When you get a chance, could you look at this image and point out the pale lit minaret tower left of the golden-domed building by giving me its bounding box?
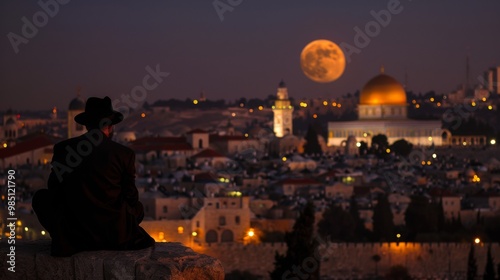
[273,80,293,137]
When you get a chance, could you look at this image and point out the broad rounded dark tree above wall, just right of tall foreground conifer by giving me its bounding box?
[318,204,356,241]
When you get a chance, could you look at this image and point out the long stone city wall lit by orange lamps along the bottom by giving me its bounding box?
[193,243,500,279]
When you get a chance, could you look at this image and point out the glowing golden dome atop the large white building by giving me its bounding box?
[359,74,406,105]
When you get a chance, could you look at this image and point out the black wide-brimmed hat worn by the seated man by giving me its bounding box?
[75,96,123,125]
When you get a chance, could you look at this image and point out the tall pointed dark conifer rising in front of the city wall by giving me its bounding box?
[269,202,321,280]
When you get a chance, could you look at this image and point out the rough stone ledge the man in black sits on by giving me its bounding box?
[0,240,224,280]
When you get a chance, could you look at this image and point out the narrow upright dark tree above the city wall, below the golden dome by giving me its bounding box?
[373,195,395,241]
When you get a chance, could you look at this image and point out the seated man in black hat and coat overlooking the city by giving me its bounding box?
[33,96,154,256]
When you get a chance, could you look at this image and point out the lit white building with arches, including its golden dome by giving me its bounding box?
[328,69,451,146]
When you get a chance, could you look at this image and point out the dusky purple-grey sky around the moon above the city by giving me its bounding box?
[0,0,500,110]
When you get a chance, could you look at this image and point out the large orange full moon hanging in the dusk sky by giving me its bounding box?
[300,40,345,83]
